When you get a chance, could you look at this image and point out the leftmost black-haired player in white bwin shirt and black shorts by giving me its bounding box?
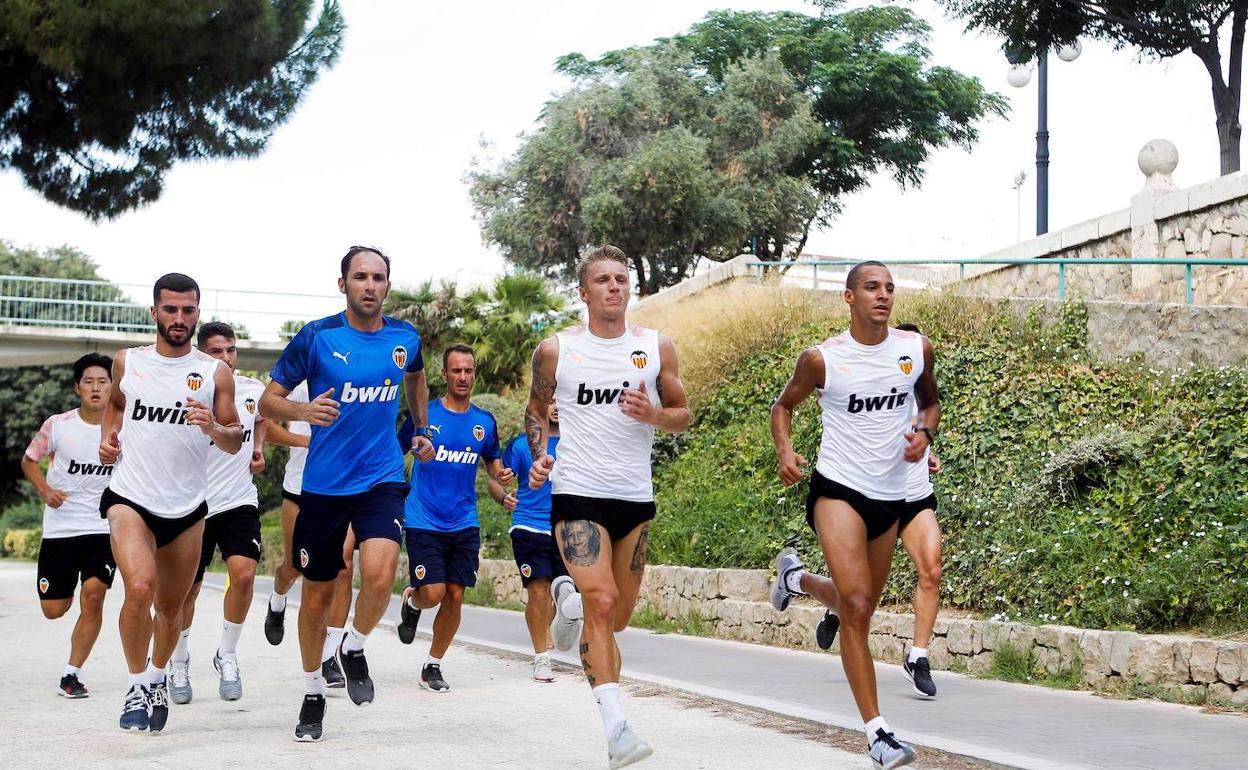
[21,353,117,698]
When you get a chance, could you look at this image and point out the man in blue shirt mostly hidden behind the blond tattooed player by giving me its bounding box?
[489,401,568,681]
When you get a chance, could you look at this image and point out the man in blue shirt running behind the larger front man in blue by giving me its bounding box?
[398,344,514,693]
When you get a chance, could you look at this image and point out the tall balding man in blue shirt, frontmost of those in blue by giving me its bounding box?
[260,246,433,741]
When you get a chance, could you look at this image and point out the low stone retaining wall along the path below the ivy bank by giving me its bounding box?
[478,559,1248,704]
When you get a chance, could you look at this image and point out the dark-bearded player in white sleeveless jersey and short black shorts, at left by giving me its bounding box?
[100,273,242,733]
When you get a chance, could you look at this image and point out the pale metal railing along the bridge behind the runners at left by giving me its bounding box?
[0,275,342,341]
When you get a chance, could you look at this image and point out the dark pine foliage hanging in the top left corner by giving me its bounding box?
[0,0,344,220]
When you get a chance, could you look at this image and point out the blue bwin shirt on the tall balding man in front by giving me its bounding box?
[271,312,424,495]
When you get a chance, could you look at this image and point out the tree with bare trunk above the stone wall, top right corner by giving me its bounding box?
[938,0,1248,173]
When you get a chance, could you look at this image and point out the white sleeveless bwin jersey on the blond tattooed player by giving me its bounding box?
[550,323,659,503]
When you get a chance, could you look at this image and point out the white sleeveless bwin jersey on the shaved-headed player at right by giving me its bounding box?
[815,329,924,500]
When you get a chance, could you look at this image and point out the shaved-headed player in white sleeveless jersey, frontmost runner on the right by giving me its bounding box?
[771,262,940,768]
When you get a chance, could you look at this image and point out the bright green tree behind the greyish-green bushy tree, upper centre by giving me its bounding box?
[558,0,1007,260]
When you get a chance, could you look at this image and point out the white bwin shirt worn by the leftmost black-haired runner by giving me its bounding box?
[26,409,112,539]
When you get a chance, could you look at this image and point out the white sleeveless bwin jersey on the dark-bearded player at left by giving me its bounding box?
[109,344,226,518]
